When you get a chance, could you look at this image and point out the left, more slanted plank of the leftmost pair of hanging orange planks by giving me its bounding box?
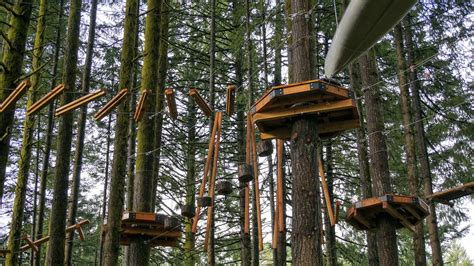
[192,112,222,233]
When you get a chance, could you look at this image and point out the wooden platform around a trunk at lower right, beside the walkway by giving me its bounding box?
[346,194,429,231]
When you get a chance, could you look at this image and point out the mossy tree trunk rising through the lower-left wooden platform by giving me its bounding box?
[130,0,161,266]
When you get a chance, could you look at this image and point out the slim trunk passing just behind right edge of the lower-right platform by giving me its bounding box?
[393,24,426,266]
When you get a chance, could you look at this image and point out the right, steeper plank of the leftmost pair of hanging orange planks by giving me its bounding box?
[204,112,222,251]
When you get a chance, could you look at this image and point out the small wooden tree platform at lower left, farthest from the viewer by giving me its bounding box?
[102,212,181,247]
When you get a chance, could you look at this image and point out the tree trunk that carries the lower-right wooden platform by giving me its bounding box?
[359,51,398,266]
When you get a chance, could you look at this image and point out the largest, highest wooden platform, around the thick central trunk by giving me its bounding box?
[251,80,359,139]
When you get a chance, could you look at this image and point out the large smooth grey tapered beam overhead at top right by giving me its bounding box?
[324,0,417,78]
